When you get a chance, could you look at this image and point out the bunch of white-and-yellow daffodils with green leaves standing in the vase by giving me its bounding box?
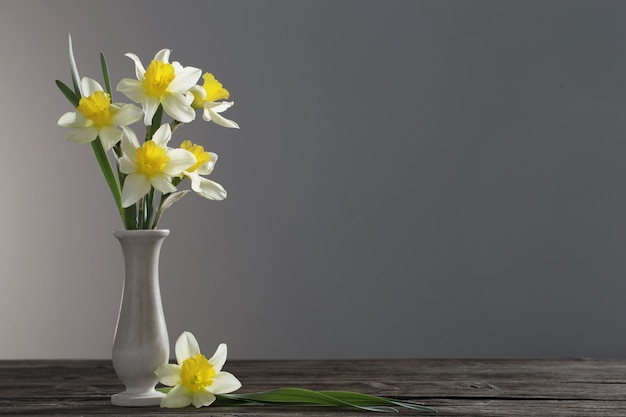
[56,37,239,230]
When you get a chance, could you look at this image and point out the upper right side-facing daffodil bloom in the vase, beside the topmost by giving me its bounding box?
[190,72,239,129]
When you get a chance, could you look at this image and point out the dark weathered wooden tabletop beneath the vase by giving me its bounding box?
[0,359,626,417]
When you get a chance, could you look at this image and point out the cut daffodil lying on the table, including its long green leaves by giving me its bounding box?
[155,332,437,413]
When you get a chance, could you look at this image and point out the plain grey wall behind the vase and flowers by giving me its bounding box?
[0,0,626,358]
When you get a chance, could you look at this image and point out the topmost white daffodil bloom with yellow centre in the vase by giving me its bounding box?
[117,49,202,126]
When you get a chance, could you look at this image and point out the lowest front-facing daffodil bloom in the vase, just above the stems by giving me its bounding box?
[120,124,196,207]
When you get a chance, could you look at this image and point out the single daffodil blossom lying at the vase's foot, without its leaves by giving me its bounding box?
[155,332,241,408]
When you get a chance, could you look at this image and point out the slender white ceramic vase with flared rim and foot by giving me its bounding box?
[111,230,170,406]
